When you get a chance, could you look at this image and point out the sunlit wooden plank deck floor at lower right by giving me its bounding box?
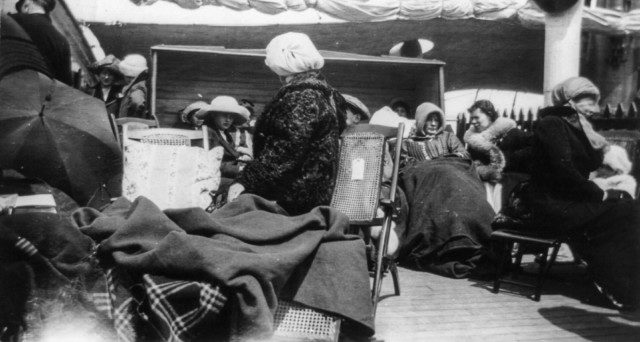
[375,255,640,342]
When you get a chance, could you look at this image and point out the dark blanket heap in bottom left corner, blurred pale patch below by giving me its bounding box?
[0,212,115,341]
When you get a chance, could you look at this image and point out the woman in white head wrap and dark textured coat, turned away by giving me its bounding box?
[228,32,346,215]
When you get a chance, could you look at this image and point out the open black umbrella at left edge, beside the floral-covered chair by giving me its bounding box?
[0,70,122,205]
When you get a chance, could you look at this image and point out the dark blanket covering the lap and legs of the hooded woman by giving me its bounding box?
[400,157,494,278]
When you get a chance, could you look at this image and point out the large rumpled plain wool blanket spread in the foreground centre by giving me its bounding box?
[76,195,373,338]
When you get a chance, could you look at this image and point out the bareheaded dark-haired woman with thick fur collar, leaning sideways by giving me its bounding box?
[464,100,531,211]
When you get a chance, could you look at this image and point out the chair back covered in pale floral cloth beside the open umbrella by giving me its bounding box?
[122,124,218,209]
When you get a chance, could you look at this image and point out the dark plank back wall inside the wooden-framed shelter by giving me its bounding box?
[157,51,439,126]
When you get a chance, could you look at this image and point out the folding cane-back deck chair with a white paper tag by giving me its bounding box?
[331,123,404,315]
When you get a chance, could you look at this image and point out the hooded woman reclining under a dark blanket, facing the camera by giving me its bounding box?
[384,103,493,278]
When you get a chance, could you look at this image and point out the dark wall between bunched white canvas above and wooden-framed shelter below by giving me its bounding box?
[90,19,544,92]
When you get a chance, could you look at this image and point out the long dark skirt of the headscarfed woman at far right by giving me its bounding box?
[528,190,640,308]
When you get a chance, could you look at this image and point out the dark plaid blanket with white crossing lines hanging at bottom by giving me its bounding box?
[97,269,227,342]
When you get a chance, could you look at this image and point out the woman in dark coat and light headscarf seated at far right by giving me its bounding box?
[522,77,640,309]
